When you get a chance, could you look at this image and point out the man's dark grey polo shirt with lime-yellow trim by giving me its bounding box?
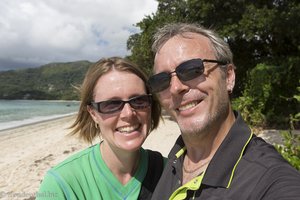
[152,112,300,200]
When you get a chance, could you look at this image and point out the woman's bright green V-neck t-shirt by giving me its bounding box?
[36,144,148,200]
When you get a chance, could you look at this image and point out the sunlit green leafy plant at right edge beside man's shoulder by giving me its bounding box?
[275,87,300,170]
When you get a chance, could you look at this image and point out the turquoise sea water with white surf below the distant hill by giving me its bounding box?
[0,100,79,130]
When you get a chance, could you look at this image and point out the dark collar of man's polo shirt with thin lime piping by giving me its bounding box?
[168,112,253,188]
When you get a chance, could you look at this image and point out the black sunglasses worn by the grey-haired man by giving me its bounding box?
[148,58,227,93]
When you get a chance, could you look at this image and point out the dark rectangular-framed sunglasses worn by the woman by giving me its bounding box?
[90,94,152,114]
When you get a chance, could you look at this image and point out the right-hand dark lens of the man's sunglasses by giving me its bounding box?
[176,59,204,81]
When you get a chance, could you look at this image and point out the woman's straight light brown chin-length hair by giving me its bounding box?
[70,57,161,143]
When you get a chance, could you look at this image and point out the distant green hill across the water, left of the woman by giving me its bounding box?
[0,61,92,100]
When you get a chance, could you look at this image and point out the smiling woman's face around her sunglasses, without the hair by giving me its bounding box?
[89,70,151,151]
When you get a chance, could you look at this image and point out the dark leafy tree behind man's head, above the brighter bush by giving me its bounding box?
[127,0,300,96]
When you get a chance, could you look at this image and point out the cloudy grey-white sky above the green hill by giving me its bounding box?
[0,0,158,71]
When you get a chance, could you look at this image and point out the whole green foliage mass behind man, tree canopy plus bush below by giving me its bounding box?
[127,0,300,126]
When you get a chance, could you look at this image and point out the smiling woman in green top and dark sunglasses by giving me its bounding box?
[37,57,163,200]
